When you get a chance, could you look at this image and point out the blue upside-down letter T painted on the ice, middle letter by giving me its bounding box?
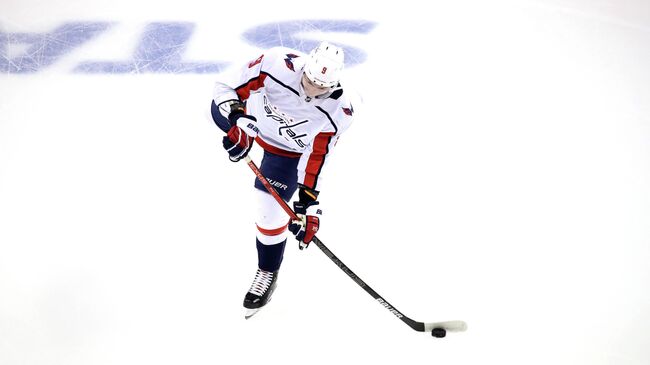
[75,23,227,74]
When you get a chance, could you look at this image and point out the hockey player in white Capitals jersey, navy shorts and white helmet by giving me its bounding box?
[211,42,354,318]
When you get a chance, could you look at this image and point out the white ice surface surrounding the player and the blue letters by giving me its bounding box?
[0,0,650,365]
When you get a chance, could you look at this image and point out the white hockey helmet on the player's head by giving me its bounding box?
[305,42,344,88]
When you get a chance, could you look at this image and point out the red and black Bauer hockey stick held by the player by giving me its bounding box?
[244,156,467,337]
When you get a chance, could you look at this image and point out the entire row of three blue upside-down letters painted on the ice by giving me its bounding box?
[0,20,376,74]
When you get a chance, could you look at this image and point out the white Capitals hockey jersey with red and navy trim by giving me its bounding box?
[214,47,354,191]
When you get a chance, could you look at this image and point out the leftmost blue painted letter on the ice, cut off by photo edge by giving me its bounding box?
[0,22,109,73]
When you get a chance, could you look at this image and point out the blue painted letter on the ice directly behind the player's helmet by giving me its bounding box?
[243,20,376,66]
